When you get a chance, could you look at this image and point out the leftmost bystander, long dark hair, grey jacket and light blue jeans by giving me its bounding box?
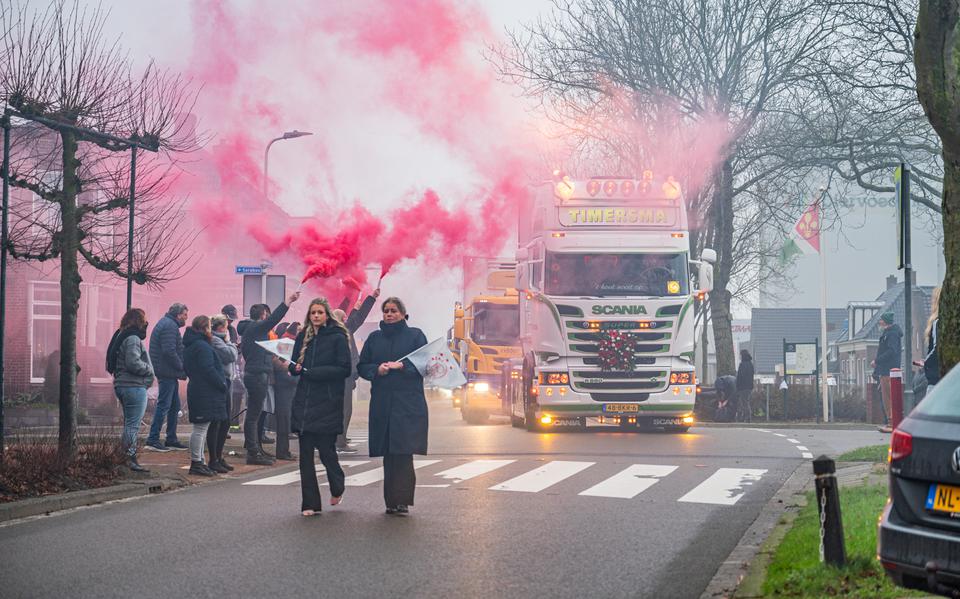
[107,308,153,472]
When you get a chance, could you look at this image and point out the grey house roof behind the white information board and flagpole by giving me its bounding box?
[750,308,847,374]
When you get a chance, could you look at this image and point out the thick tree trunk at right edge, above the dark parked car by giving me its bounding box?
[914,0,960,374]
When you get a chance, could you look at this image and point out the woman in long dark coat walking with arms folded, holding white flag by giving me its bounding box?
[357,297,428,515]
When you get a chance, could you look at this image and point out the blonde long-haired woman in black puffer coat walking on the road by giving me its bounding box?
[289,298,350,516]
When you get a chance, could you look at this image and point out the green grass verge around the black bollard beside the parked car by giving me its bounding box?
[763,485,926,599]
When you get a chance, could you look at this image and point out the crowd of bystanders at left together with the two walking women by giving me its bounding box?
[106,289,428,516]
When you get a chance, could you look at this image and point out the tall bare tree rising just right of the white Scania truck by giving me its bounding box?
[496,0,837,374]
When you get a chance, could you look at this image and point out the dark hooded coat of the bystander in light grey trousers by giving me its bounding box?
[183,327,230,422]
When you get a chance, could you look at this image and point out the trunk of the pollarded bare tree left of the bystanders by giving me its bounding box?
[59,132,81,463]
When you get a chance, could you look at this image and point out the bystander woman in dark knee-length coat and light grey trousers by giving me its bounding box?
[183,316,229,476]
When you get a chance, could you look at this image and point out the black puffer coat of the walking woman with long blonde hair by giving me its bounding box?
[290,324,350,435]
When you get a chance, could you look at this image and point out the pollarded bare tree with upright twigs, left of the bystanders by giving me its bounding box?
[0,0,195,460]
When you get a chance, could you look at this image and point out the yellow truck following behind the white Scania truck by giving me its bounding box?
[452,257,520,424]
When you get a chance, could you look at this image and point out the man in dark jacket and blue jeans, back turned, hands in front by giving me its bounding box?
[146,303,189,451]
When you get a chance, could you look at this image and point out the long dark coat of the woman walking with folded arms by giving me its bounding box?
[357,320,429,457]
